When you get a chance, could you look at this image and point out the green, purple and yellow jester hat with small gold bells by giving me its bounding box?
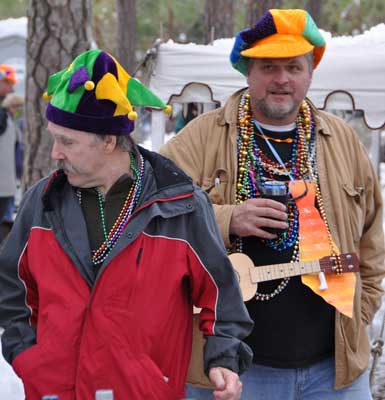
[43,49,171,135]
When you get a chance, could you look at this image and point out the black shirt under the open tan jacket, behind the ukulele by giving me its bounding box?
[243,130,335,368]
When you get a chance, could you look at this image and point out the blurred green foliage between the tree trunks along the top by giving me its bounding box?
[0,0,385,60]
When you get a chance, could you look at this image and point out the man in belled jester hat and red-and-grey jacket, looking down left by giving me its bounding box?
[0,50,253,400]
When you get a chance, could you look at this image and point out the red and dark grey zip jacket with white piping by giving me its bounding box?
[0,149,252,400]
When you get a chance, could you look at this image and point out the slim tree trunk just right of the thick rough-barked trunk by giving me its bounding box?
[115,0,136,74]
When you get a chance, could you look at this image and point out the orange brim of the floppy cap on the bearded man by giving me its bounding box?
[241,33,325,68]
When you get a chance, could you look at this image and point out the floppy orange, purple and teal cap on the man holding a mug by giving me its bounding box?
[230,9,326,75]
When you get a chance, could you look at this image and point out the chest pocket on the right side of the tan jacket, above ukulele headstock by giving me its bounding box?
[342,183,365,243]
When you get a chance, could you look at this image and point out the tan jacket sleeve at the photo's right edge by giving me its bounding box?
[360,145,385,324]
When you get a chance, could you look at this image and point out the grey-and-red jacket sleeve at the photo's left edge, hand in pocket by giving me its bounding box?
[0,184,38,364]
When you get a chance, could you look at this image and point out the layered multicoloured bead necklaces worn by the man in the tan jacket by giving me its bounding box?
[236,92,320,301]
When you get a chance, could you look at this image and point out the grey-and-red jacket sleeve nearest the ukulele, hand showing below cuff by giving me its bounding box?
[185,188,253,374]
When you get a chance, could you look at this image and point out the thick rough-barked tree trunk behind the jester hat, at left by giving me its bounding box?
[23,0,92,189]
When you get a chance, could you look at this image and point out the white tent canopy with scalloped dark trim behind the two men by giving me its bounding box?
[149,24,385,149]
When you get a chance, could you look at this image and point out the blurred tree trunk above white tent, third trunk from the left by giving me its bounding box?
[205,0,234,44]
